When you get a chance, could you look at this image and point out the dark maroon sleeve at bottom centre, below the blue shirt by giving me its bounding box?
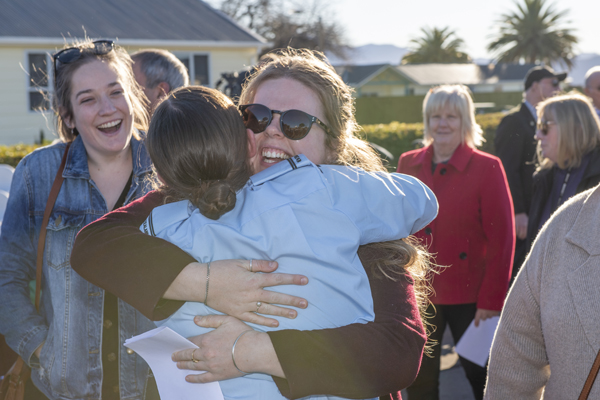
[269,242,426,399]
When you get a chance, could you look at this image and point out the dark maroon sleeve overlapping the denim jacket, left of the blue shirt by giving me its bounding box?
[71,192,196,321]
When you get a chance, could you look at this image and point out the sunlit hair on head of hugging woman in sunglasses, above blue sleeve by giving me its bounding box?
[240,48,386,171]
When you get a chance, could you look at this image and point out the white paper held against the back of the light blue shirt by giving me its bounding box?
[125,326,223,400]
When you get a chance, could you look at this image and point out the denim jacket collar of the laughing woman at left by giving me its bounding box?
[63,132,152,179]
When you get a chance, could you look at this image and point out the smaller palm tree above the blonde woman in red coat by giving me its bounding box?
[402,27,471,64]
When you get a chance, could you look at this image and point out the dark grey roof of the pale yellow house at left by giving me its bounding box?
[0,0,266,46]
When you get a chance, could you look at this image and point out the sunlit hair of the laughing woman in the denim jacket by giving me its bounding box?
[52,39,148,142]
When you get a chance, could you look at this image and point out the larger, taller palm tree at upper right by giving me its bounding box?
[488,0,578,68]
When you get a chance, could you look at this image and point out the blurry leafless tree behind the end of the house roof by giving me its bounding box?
[220,0,348,57]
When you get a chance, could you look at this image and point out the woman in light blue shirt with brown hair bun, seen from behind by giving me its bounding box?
[137,83,437,400]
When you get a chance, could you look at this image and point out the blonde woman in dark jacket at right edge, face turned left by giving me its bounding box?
[527,92,600,248]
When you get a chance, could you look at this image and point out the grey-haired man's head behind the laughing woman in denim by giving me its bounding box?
[131,49,190,115]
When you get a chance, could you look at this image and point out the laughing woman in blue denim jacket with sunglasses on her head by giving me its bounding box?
[0,40,153,399]
